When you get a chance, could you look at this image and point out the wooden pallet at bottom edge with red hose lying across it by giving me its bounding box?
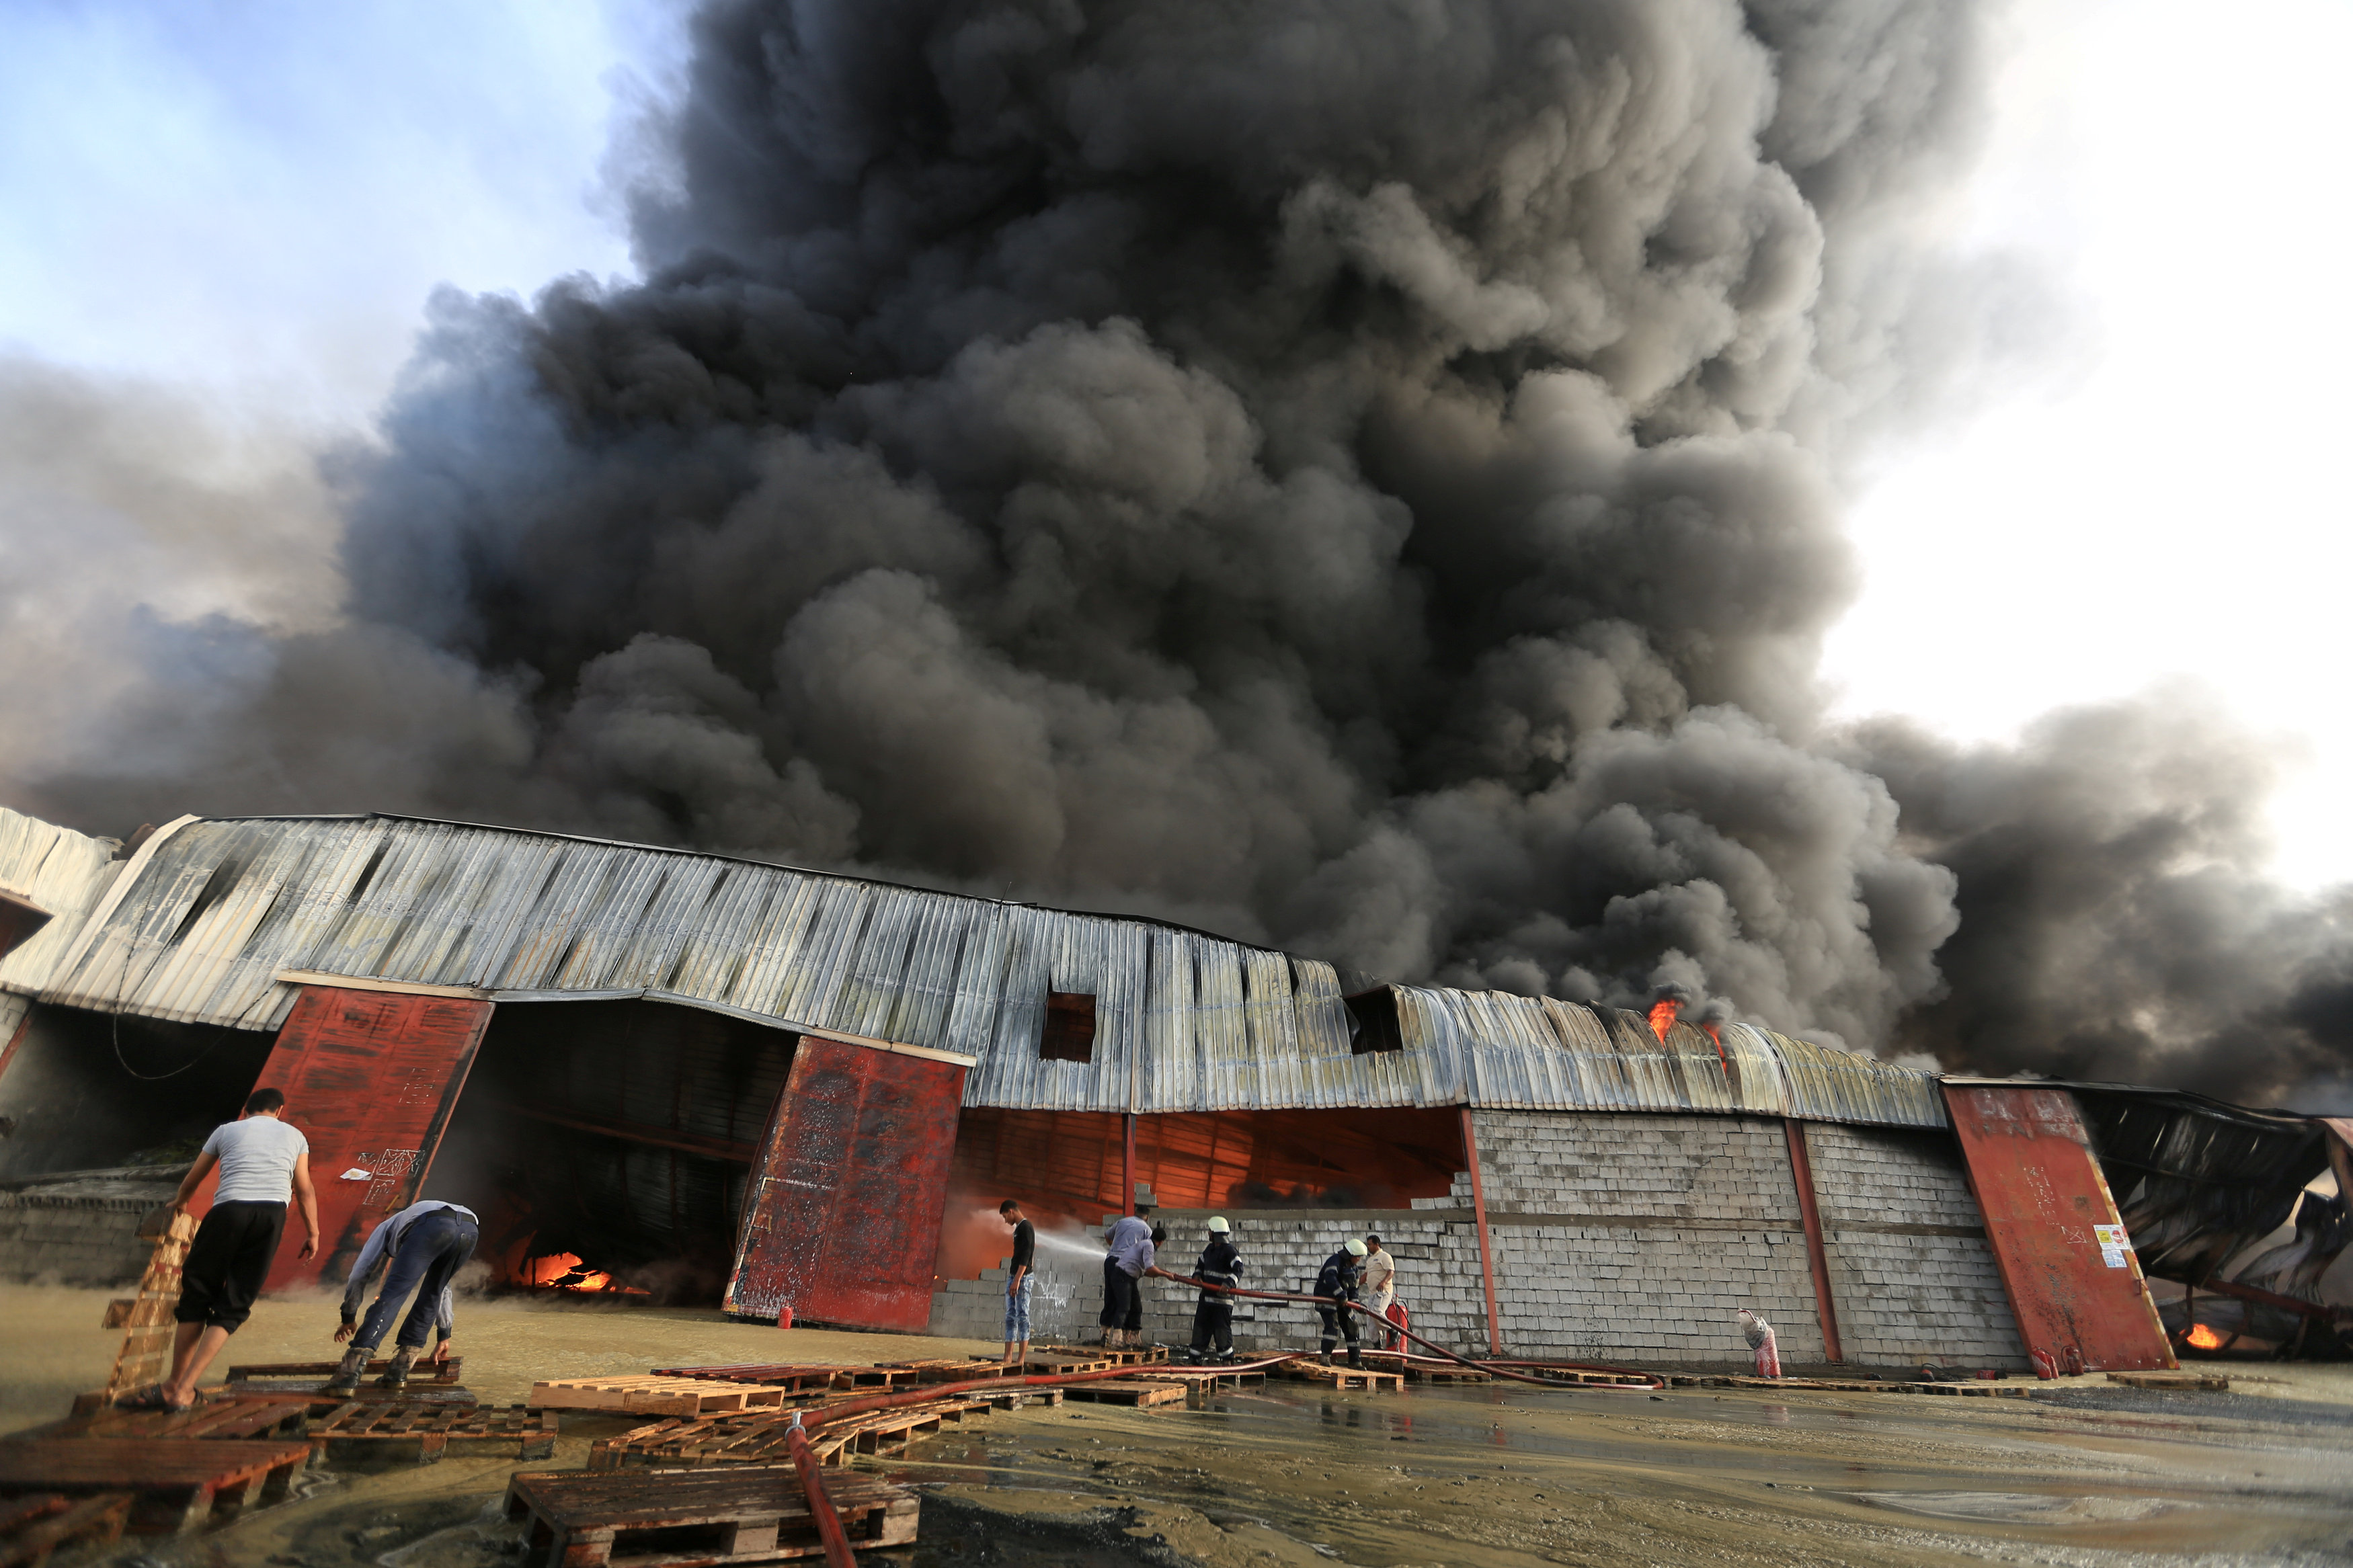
[506,1464,920,1568]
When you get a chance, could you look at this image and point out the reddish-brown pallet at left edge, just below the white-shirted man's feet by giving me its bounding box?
[0,1436,311,1535]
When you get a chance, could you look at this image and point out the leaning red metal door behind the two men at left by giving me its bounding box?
[202,985,492,1290]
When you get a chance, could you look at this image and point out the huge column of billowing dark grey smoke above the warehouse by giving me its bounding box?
[4,0,2334,1104]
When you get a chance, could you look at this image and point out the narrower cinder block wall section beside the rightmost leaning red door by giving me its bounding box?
[1805,1121,2028,1370]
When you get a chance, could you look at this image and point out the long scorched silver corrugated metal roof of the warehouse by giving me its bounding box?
[42,816,1944,1126]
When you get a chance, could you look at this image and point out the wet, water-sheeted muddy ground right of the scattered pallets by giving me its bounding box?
[866,1383,2353,1568]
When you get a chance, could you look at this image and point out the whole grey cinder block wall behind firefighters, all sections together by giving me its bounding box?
[932,1112,2026,1368]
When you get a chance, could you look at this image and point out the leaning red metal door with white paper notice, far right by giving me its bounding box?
[1944,1083,2174,1373]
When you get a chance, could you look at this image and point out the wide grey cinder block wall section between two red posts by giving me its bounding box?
[1457,1112,1824,1364]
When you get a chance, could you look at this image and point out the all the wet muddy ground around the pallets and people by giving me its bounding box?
[0,1288,2353,1568]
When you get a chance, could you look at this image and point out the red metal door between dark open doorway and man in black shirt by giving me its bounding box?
[725,1034,965,1331]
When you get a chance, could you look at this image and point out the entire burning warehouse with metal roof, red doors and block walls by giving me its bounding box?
[0,813,2353,1370]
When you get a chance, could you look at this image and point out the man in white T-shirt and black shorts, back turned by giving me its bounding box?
[122,1088,318,1411]
